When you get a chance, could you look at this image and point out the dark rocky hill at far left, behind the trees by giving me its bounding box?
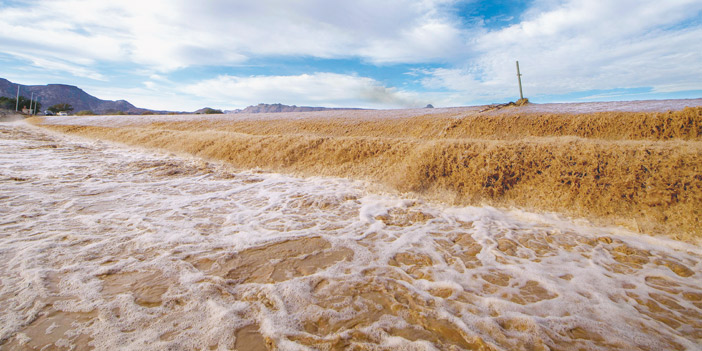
[0,78,153,114]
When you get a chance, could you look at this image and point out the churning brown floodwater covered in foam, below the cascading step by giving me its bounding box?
[0,122,702,350]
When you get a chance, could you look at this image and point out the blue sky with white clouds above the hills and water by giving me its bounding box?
[0,0,702,111]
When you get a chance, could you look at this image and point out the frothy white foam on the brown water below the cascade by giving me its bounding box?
[0,124,702,350]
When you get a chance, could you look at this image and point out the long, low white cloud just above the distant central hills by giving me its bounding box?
[182,73,428,108]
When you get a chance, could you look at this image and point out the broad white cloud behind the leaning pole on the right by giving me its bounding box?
[423,0,702,101]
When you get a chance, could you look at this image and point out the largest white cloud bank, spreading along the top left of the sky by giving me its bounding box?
[0,0,472,72]
